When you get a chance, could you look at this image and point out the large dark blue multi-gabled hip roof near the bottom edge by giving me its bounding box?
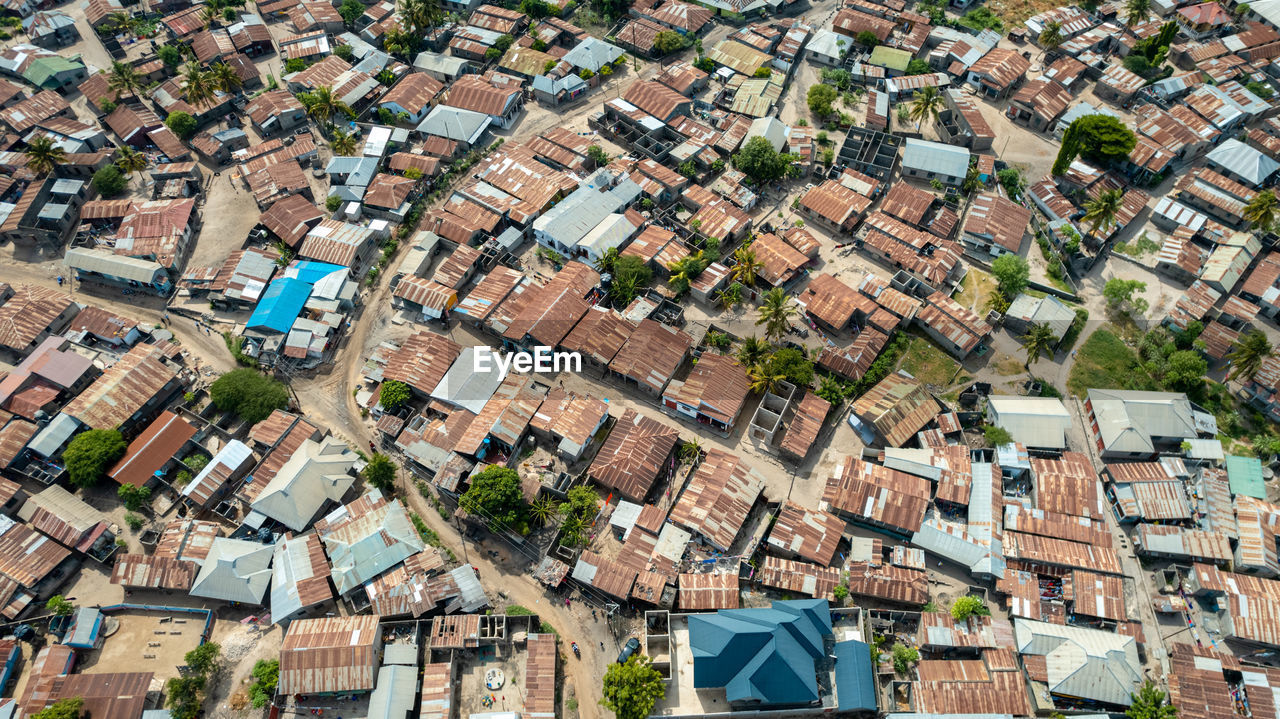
[689,599,834,706]
